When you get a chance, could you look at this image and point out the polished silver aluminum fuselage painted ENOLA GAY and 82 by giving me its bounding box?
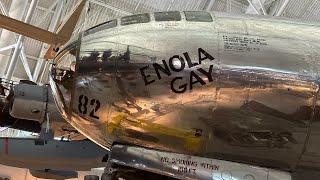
[51,13,320,170]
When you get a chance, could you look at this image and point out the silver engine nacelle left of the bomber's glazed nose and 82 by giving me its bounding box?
[10,84,64,122]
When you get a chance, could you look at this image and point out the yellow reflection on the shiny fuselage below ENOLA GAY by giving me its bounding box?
[106,114,204,153]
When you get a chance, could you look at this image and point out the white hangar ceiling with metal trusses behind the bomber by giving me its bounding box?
[0,0,320,84]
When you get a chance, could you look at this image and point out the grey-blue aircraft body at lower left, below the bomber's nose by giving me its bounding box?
[0,138,107,179]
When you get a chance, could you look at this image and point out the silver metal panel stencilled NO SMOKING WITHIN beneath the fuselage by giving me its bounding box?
[110,145,291,180]
